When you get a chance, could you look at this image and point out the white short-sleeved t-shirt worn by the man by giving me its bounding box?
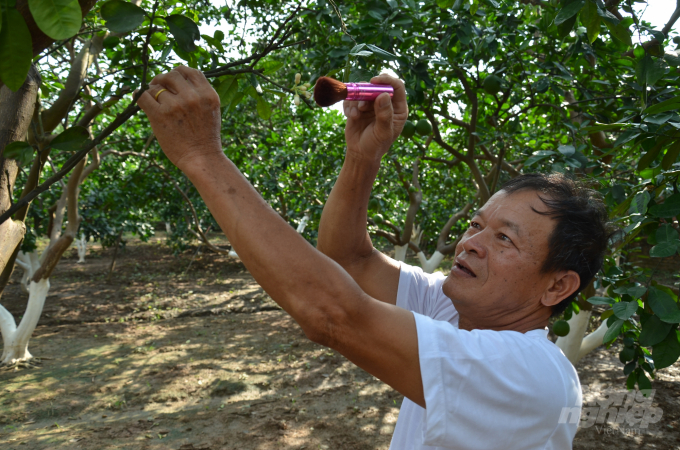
[390,264,582,450]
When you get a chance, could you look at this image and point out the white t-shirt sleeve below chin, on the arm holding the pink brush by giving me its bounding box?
[397,263,458,322]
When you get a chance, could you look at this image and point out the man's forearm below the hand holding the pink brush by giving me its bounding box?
[317,156,380,267]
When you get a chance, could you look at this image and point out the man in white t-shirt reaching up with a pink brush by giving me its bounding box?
[138,67,608,450]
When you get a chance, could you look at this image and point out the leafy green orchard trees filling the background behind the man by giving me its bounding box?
[0,0,680,388]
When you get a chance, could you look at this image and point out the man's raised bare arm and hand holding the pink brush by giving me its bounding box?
[317,74,408,304]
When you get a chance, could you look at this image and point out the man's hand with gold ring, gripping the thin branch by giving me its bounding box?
[137,66,222,170]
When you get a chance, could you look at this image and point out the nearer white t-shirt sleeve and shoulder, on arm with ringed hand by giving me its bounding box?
[414,314,578,450]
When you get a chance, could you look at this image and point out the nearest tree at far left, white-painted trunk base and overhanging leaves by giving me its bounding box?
[0,0,314,365]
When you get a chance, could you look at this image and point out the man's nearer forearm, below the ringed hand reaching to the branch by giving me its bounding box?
[182,154,365,337]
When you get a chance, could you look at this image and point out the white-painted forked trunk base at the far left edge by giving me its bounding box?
[0,278,50,364]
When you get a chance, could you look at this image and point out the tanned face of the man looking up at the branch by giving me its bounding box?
[443,191,555,321]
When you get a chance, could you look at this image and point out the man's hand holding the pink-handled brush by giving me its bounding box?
[343,73,408,162]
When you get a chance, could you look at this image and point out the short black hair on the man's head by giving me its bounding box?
[501,173,615,317]
